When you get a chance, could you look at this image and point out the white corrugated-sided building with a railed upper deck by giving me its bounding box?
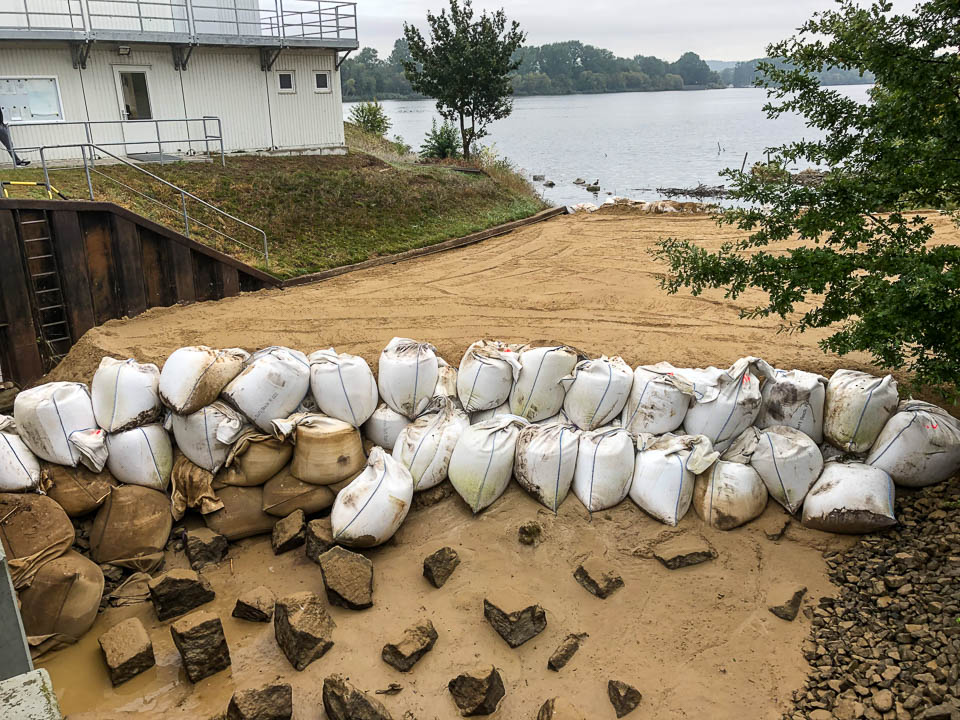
[0,0,358,162]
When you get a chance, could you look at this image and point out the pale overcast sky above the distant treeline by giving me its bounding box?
[357,0,915,60]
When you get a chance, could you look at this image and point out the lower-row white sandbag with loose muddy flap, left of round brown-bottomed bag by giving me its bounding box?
[630,435,719,526]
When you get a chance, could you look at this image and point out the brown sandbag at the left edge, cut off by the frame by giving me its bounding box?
[0,493,74,590]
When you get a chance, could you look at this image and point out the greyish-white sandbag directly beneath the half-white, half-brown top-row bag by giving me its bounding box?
[167,400,250,473]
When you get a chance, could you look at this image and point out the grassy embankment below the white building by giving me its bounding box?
[0,126,545,278]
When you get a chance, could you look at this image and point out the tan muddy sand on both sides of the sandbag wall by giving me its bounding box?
[39,212,960,720]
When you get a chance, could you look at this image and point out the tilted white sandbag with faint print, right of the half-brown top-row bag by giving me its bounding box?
[223,347,310,433]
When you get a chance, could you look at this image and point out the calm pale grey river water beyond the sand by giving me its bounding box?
[344,85,870,205]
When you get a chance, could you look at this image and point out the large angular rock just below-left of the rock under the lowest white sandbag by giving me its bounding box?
[273,592,337,670]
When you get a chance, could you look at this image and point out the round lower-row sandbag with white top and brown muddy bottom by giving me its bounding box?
[693,460,768,530]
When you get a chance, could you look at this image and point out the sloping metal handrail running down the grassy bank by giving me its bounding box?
[40,143,270,267]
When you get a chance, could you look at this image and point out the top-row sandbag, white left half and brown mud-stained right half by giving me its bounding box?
[158,345,250,415]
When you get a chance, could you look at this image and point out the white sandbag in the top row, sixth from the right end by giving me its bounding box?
[561,355,633,430]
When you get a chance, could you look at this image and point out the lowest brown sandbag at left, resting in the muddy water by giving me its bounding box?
[20,550,103,657]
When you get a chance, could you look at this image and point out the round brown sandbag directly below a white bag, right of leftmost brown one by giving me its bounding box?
[90,485,173,572]
